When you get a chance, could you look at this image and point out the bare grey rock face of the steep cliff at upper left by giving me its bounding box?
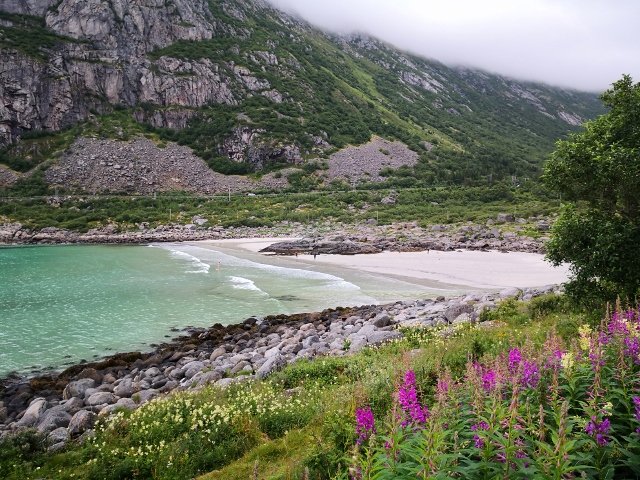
[0,0,238,146]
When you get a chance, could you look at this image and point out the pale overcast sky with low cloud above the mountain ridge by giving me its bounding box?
[270,0,640,92]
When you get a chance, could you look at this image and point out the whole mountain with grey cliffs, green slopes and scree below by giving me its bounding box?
[0,0,604,192]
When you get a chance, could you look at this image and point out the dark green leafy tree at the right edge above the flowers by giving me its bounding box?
[544,75,640,301]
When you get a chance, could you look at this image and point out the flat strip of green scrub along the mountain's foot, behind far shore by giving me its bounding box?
[0,182,558,235]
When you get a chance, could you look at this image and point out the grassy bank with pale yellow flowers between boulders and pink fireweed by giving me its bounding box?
[0,297,604,480]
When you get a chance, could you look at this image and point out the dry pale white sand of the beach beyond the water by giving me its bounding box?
[198,238,568,290]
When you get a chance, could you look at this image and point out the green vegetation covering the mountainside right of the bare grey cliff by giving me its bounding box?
[144,2,601,182]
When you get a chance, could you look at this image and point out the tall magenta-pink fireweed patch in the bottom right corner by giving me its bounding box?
[348,309,640,480]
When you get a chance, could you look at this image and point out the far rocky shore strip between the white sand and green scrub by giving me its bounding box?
[0,215,550,255]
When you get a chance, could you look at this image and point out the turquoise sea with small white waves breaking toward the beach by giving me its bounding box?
[0,244,450,377]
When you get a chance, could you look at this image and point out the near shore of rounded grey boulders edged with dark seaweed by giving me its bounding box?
[0,286,559,450]
